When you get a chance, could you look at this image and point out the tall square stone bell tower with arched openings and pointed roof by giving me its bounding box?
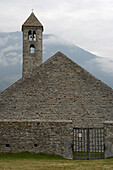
[22,12,43,76]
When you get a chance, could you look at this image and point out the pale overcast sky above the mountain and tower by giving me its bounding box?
[0,0,113,60]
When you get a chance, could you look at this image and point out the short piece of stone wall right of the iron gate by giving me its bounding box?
[104,121,113,158]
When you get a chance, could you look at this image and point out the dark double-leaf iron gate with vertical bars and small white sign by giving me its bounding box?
[73,128,104,159]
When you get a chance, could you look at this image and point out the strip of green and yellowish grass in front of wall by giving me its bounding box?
[0,153,113,170]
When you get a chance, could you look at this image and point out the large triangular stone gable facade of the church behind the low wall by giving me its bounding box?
[0,52,113,127]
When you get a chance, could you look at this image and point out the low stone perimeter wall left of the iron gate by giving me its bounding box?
[0,120,73,158]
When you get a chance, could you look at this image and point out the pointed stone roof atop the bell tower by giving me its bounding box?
[22,12,43,31]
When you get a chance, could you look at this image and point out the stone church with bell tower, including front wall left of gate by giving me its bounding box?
[0,12,113,158]
